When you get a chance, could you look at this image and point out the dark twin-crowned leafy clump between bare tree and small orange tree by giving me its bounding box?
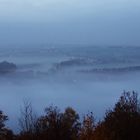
[37,106,80,140]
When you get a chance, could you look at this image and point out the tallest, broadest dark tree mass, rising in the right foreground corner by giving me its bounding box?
[95,92,140,140]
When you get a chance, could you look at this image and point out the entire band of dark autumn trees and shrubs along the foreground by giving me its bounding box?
[0,92,140,140]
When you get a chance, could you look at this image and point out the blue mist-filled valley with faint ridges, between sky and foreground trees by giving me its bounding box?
[0,46,140,132]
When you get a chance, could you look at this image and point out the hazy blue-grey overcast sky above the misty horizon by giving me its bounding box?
[0,0,140,46]
